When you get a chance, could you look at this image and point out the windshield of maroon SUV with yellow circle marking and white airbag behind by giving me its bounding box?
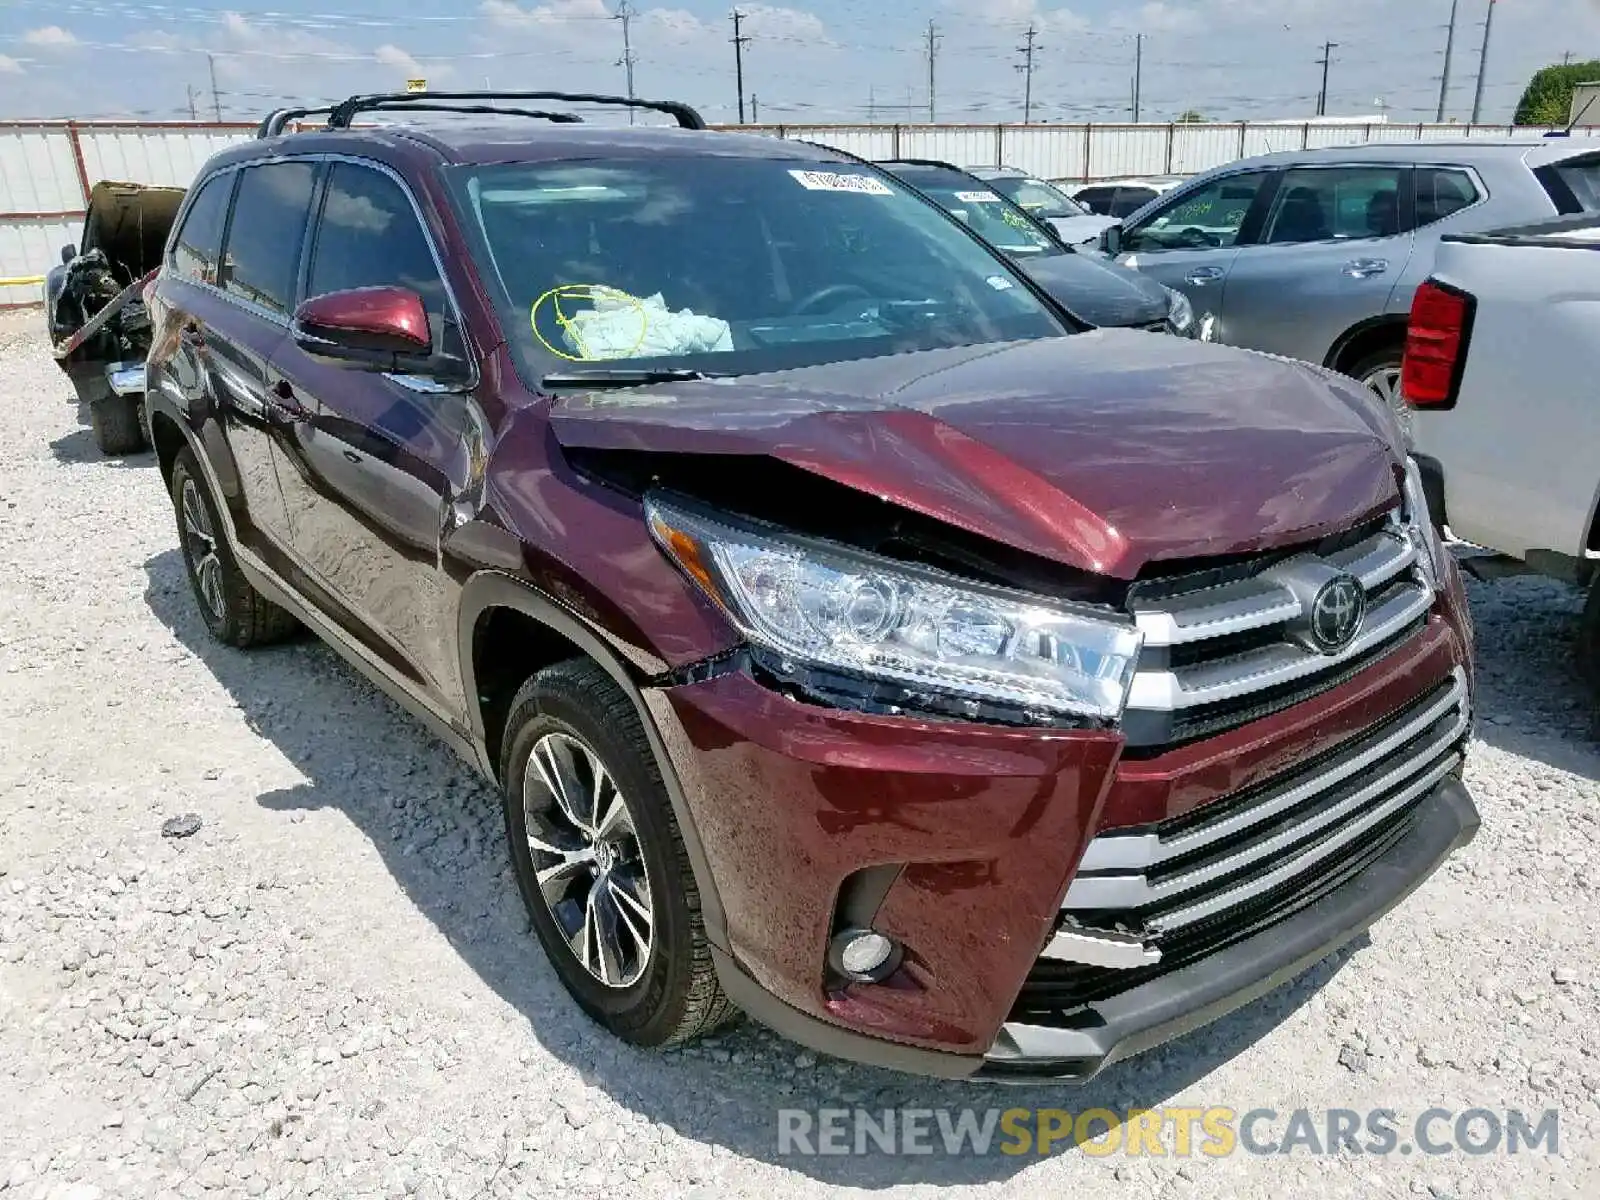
[446,157,1067,384]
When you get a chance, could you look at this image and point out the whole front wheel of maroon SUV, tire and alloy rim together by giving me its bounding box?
[501,659,738,1046]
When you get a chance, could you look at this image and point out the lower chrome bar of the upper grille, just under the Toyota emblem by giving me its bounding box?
[1128,584,1434,710]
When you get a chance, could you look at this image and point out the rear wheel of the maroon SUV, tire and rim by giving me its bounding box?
[173,446,299,650]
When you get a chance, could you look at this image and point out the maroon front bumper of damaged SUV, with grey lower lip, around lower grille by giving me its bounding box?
[645,605,1477,1078]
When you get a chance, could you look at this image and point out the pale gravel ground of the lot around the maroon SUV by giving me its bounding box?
[0,312,1600,1200]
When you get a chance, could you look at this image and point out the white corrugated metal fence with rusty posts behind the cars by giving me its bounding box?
[0,122,1600,306]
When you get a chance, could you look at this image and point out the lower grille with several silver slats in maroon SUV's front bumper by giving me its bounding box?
[1045,669,1470,957]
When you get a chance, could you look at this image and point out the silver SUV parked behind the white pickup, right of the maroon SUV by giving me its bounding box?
[1104,138,1600,416]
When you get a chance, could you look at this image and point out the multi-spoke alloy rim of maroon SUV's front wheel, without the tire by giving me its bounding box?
[522,733,654,987]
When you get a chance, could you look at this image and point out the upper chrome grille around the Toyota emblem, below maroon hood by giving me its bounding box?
[1125,514,1434,747]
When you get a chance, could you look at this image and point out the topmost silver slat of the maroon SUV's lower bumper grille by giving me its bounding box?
[1078,667,1467,872]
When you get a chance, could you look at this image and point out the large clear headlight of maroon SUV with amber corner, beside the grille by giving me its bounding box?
[645,498,1144,718]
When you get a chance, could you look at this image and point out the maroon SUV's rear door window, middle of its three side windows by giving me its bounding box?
[221,162,317,314]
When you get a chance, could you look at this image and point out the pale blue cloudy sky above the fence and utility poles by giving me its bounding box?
[0,0,1600,123]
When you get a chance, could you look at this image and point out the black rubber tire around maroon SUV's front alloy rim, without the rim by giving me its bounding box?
[501,659,741,1046]
